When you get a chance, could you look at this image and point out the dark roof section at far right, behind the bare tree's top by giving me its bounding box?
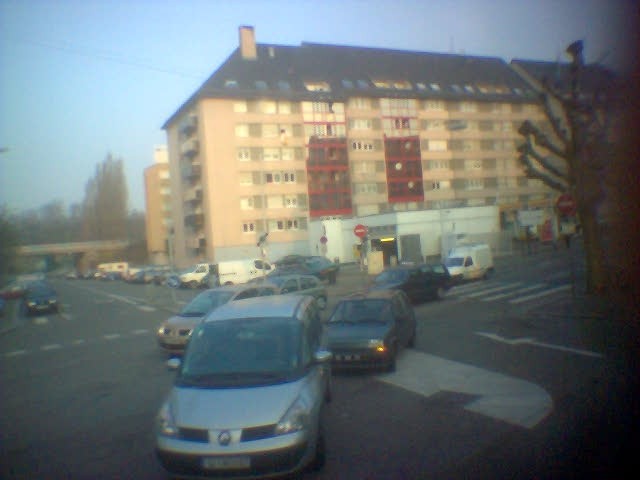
[511,59,616,94]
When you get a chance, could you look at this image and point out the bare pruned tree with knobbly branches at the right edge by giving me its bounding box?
[518,41,616,293]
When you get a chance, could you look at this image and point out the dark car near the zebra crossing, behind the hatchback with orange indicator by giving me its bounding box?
[369,263,453,303]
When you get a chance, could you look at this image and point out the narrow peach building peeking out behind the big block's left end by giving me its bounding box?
[144,145,173,265]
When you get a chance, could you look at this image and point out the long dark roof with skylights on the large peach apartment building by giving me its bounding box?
[163,43,535,128]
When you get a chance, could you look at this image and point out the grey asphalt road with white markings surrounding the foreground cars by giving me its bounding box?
[0,246,638,479]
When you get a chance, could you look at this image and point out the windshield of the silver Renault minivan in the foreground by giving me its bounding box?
[176,318,302,387]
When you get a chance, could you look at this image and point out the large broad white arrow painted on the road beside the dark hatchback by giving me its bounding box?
[377,350,553,428]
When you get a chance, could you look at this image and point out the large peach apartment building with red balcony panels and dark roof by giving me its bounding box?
[163,27,556,265]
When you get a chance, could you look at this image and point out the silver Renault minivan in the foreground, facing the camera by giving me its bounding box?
[156,295,331,479]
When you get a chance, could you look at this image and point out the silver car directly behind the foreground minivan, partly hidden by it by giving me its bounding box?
[157,284,279,354]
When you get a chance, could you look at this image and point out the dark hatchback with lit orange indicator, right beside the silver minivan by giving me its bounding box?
[327,290,416,371]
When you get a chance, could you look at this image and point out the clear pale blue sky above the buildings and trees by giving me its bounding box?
[0,0,639,213]
